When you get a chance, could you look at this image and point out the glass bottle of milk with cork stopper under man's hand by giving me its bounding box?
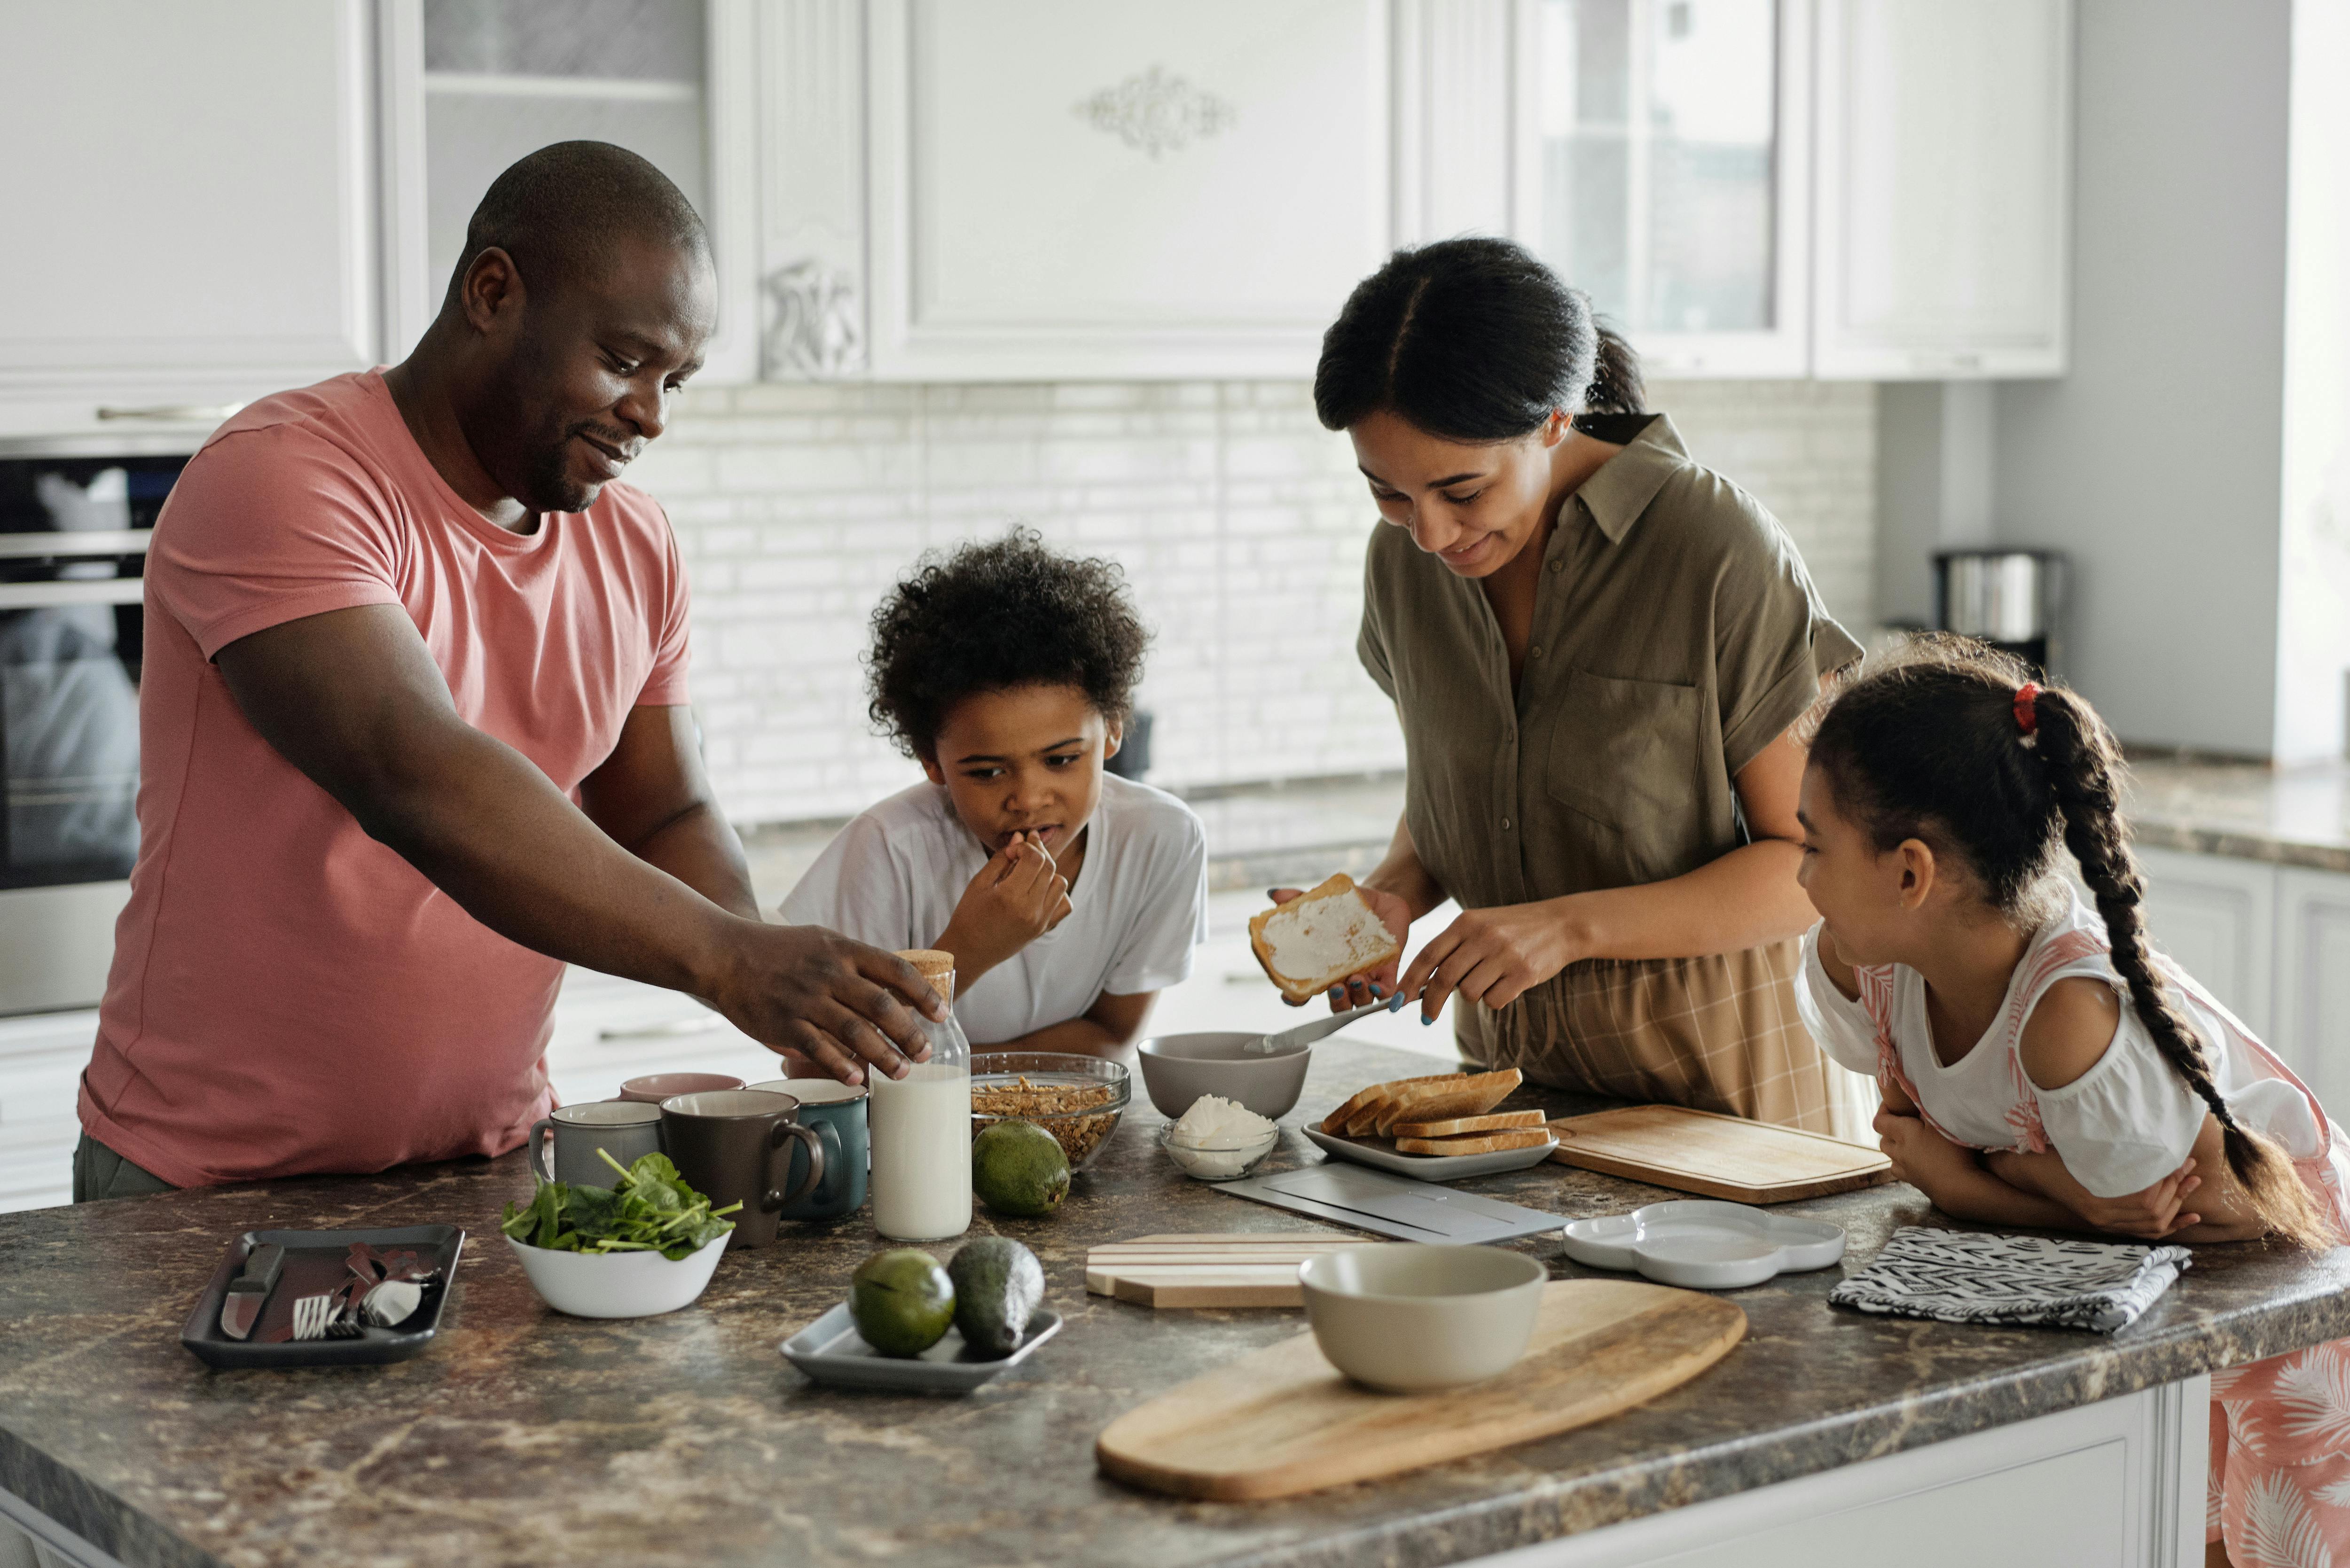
[867,950,971,1241]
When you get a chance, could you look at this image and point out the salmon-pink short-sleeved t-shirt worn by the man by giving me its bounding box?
[80,371,686,1187]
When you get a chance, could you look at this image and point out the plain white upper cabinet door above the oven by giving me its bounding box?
[0,0,376,447]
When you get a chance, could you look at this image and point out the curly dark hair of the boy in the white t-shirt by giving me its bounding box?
[865,529,1149,759]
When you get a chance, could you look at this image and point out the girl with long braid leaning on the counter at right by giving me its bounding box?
[1795,637,2350,1568]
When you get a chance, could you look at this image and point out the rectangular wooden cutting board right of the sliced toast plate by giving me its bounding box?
[1551,1105,1892,1204]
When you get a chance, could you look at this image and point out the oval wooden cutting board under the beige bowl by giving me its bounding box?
[1093,1279,1746,1502]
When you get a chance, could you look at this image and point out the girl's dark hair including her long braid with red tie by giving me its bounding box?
[1812,635,2338,1248]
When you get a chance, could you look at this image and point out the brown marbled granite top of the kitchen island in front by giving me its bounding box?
[0,1039,2350,1568]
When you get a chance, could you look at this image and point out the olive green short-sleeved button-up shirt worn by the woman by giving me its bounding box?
[1358,414,1861,910]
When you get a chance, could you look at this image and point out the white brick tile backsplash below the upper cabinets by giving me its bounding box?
[632,381,1875,823]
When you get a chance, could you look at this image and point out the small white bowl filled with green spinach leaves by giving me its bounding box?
[498,1154,738,1317]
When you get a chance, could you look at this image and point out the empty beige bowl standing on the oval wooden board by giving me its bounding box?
[1297,1241,1551,1394]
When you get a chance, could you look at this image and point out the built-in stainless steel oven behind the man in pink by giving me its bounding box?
[0,456,186,1013]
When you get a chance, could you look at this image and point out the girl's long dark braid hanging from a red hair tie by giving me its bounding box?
[2016,686,2341,1251]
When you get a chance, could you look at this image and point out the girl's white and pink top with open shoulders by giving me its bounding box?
[1795,893,2350,1234]
